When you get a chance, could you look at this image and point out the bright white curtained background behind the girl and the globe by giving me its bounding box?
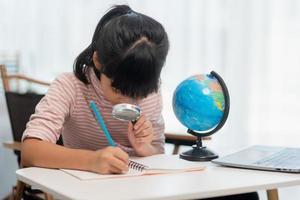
[0,0,300,199]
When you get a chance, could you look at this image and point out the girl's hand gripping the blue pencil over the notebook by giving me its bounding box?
[90,147,129,174]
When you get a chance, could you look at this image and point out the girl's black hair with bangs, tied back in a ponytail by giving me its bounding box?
[74,5,169,98]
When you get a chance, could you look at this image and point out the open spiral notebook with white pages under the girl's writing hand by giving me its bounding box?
[61,154,205,180]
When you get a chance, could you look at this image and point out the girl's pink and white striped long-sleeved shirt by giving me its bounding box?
[22,69,165,154]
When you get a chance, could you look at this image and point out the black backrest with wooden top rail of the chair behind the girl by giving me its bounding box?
[0,65,63,165]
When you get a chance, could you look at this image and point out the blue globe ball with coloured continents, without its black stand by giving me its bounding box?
[173,74,225,133]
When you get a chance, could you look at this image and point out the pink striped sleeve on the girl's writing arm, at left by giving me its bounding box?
[22,73,76,143]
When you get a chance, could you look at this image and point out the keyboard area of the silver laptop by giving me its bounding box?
[254,148,300,169]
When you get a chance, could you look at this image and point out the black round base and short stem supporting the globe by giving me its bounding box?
[179,129,219,161]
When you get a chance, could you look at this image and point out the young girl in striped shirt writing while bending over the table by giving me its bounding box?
[22,5,169,174]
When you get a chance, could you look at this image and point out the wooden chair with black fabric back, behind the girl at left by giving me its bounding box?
[0,65,55,200]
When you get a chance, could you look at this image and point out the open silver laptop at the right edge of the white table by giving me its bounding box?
[212,145,300,173]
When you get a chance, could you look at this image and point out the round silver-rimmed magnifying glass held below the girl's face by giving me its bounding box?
[112,103,141,124]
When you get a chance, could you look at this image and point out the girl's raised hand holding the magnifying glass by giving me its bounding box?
[128,115,154,156]
